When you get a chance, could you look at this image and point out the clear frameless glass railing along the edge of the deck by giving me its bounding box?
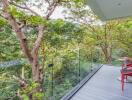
[44,49,102,100]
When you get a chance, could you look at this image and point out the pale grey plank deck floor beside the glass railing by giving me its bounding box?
[70,65,132,100]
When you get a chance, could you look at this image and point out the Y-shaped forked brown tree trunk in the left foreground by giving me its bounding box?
[2,0,44,100]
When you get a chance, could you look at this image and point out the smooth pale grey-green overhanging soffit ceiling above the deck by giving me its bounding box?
[87,0,132,20]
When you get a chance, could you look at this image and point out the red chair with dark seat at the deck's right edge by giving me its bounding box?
[121,64,132,91]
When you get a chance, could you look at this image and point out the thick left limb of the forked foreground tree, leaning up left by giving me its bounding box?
[2,0,33,63]
